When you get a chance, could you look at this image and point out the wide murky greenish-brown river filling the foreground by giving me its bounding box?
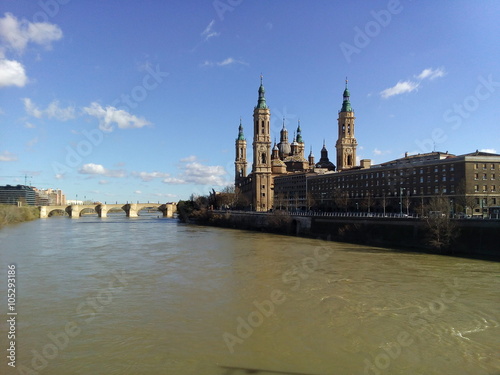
[0,214,500,375]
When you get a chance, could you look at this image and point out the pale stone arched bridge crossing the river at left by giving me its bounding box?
[39,203,177,219]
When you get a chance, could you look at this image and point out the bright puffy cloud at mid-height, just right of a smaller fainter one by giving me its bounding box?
[83,102,151,132]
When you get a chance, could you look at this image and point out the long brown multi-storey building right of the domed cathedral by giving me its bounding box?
[307,151,500,215]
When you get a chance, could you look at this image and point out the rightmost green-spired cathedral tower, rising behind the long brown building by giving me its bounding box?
[335,79,358,171]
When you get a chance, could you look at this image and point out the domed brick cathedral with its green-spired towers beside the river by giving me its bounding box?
[235,76,357,212]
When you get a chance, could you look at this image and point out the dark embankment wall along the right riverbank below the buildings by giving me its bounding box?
[200,211,500,258]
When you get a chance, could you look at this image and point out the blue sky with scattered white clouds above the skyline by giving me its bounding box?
[0,0,500,202]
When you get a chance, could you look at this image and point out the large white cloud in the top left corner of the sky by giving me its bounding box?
[0,13,63,53]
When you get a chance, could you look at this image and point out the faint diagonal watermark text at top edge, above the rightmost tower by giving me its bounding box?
[339,0,403,63]
